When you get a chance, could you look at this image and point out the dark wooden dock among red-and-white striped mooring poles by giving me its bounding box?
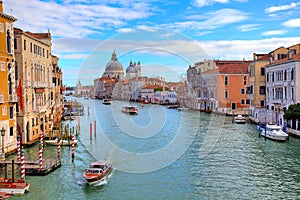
[0,159,61,176]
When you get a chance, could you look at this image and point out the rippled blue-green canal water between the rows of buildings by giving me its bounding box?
[10,98,300,200]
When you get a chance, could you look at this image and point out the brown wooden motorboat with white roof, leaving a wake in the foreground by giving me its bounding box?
[83,160,112,185]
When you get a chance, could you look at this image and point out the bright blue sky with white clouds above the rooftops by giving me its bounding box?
[3,0,300,85]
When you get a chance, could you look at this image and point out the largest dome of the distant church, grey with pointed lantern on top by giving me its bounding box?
[103,51,124,78]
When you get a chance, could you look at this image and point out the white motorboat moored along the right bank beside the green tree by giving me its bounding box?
[259,123,289,141]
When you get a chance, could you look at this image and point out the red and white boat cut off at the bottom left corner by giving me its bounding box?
[0,178,30,195]
